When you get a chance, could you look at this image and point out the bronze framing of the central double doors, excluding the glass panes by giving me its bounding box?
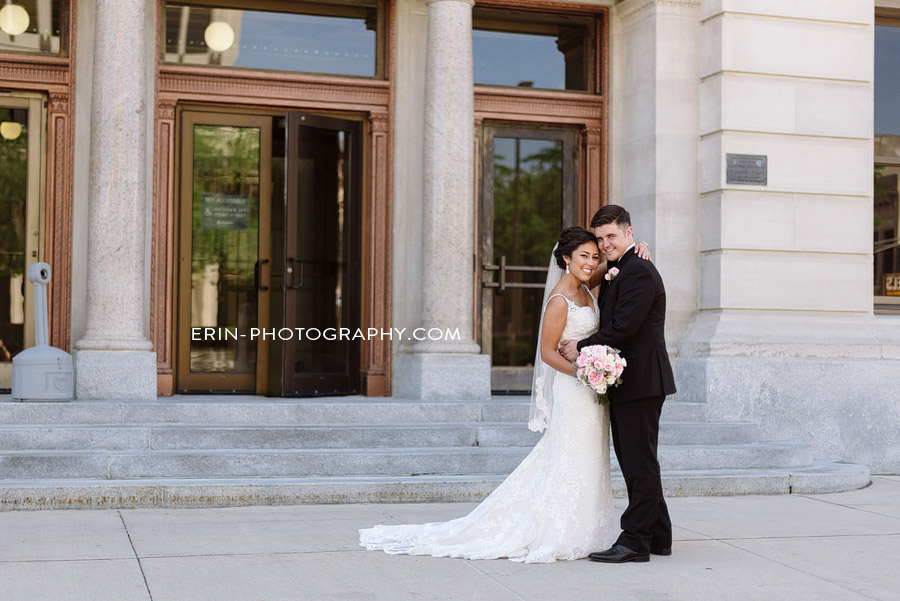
[173,106,366,396]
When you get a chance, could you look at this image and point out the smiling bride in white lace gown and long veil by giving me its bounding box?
[359,227,632,563]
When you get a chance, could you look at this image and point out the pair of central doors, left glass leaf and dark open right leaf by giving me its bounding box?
[176,110,363,396]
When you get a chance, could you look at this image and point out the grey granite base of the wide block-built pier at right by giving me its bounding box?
[674,357,900,474]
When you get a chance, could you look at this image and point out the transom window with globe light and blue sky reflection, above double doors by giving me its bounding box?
[163,2,379,77]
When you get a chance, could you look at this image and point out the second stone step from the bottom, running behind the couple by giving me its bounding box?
[0,442,813,480]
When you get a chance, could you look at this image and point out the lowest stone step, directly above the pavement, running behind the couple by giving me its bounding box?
[0,463,870,511]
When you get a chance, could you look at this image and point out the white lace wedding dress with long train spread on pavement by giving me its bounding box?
[359,295,613,563]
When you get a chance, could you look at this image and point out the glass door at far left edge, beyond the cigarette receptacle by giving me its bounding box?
[0,94,44,391]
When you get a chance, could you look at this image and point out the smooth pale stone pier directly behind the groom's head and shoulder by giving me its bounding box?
[610,0,701,354]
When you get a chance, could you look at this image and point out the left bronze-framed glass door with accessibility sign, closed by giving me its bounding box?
[176,111,272,394]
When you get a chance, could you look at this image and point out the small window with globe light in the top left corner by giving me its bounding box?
[0,0,68,55]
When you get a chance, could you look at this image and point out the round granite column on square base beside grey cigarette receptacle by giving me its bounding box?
[75,0,156,400]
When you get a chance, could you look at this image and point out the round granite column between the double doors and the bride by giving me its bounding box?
[395,0,490,399]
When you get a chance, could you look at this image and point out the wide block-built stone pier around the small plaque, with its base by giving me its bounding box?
[675,0,900,473]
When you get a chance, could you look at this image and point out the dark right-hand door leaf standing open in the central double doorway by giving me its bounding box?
[270,113,362,396]
